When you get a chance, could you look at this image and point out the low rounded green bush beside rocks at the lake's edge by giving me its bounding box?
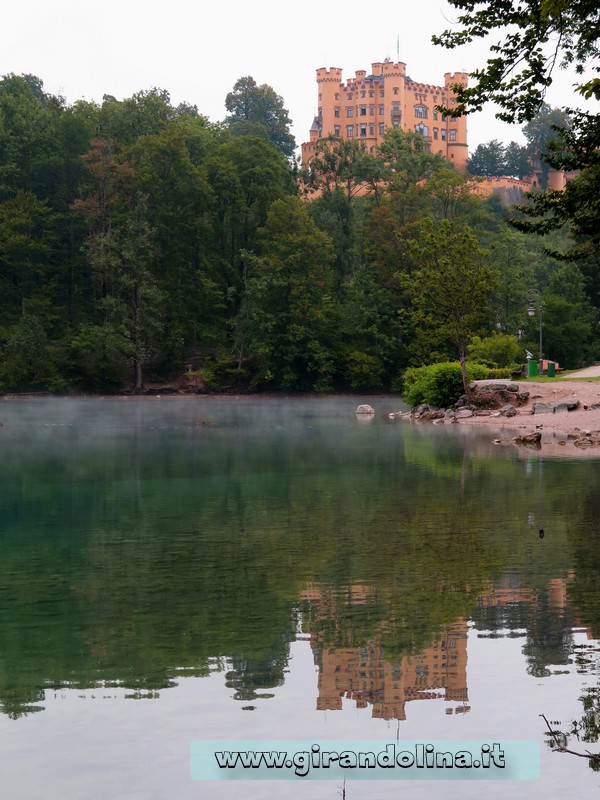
[402,361,489,408]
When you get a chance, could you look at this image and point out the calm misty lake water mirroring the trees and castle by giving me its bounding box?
[0,398,600,800]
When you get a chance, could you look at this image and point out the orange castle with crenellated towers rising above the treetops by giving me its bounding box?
[302,59,469,171]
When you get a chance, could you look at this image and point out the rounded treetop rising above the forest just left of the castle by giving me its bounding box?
[225,75,296,159]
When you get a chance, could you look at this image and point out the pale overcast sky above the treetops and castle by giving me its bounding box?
[0,0,575,152]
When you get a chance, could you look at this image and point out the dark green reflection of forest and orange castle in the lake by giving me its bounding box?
[0,401,600,716]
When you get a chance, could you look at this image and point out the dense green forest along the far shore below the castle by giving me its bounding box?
[0,74,600,393]
